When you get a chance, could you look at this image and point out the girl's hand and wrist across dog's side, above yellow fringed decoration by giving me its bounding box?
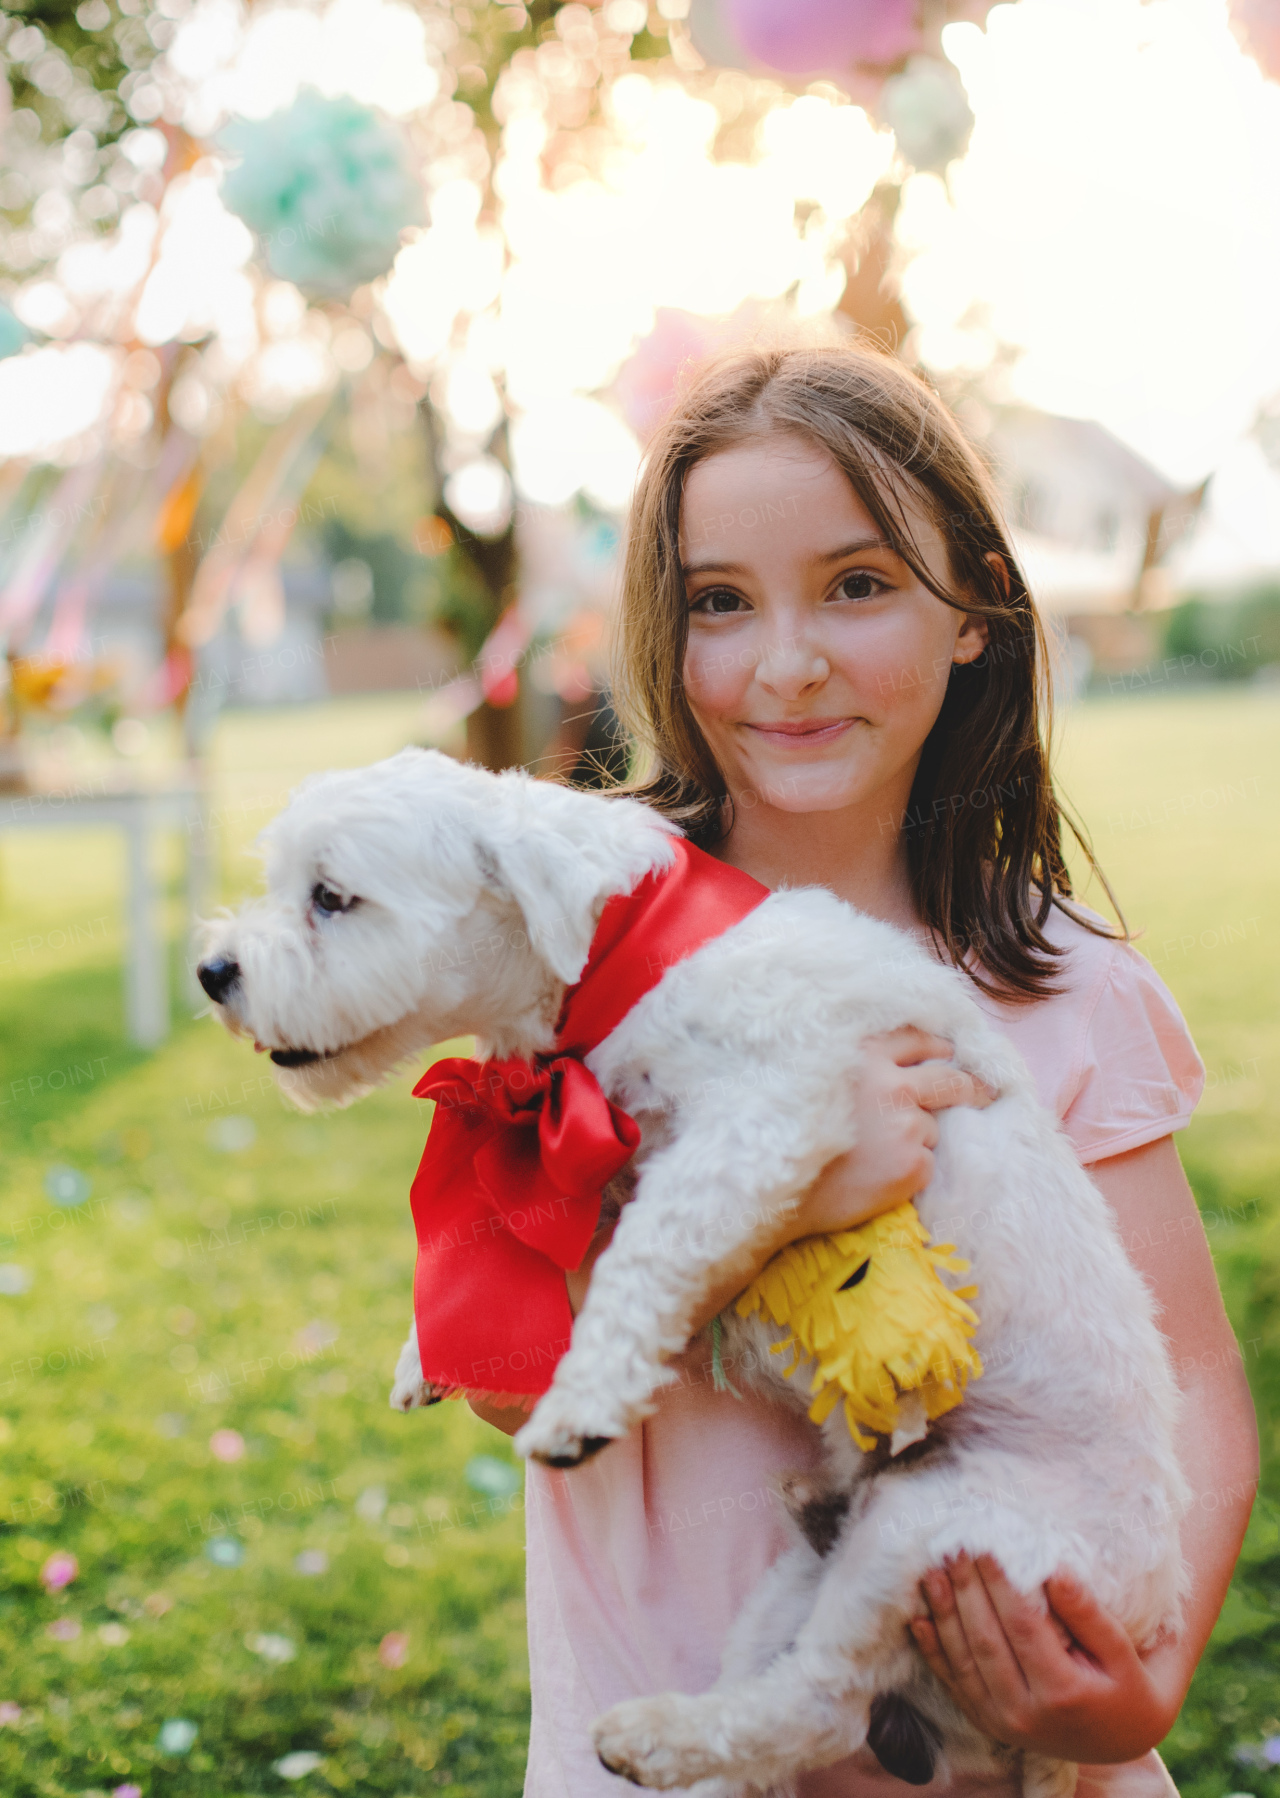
[791,1028,996,1248]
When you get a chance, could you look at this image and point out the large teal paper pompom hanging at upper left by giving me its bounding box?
[219,93,424,298]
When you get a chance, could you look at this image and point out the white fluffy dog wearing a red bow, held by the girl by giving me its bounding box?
[201,750,1185,1798]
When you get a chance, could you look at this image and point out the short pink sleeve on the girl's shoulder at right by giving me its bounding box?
[1062,942,1204,1167]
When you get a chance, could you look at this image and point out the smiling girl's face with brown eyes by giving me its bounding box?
[680,433,987,813]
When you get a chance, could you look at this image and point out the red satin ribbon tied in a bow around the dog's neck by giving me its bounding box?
[412,838,768,1393]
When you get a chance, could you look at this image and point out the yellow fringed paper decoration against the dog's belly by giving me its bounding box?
[737,1203,982,1449]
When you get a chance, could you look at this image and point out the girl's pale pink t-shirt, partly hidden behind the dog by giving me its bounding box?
[525,910,1204,1798]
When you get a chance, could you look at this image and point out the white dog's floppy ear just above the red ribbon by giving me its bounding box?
[476,818,609,985]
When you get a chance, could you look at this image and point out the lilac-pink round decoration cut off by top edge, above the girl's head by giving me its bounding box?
[721,0,919,76]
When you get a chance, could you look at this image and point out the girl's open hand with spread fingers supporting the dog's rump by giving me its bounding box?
[911,1555,1181,1764]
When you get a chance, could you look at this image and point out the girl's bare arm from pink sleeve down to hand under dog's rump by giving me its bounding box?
[913,1136,1258,1764]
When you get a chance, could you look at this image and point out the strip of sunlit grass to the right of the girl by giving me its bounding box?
[1061,694,1280,1798]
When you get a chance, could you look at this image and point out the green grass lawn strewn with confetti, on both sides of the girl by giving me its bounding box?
[0,690,1280,1798]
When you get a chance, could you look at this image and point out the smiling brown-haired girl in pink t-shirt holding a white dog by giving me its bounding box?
[476,347,1257,1798]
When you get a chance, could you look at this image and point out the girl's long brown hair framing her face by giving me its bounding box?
[615,343,1115,1000]
